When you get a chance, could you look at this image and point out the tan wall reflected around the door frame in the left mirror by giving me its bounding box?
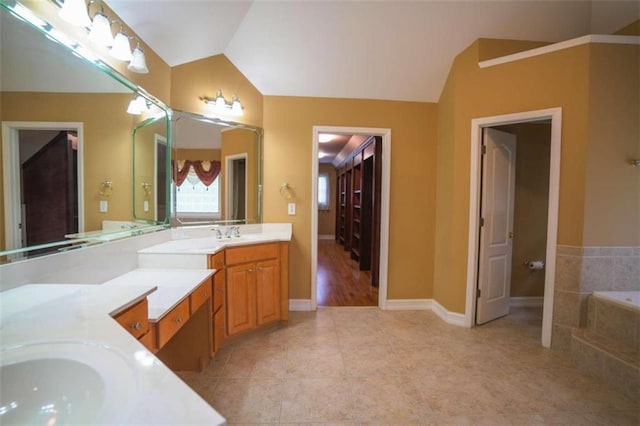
[0,92,134,236]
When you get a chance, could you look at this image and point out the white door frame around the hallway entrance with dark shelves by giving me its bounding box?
[310,126,391,310]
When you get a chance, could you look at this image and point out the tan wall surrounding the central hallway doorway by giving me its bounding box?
[264,96,437,299]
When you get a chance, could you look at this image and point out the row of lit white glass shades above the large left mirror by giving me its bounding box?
[52,0,149,74]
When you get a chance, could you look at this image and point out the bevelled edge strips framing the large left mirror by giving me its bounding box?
[0,0,171,264]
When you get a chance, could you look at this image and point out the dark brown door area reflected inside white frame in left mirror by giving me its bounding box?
[18,129,79,251]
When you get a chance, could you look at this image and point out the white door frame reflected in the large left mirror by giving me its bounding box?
[2,121,84,250]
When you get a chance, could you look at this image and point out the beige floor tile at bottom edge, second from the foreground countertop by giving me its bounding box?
[280,378,356,423]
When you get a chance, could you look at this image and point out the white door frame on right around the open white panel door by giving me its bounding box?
[465,108,562,347]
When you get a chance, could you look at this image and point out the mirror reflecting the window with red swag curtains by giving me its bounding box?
[171,111,262,226]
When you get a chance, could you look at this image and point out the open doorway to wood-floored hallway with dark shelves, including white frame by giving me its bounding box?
[309,126,391,310]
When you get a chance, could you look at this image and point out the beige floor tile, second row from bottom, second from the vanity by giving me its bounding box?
[286,346,346,378]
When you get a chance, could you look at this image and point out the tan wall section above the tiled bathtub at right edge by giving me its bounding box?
[583,44,640,246]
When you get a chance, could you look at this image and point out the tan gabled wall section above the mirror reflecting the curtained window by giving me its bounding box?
[171,55,263,127]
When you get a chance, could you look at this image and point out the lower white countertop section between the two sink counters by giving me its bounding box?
[103,269,215,321]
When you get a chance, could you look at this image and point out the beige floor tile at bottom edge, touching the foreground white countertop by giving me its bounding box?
[209,378,283,423]
